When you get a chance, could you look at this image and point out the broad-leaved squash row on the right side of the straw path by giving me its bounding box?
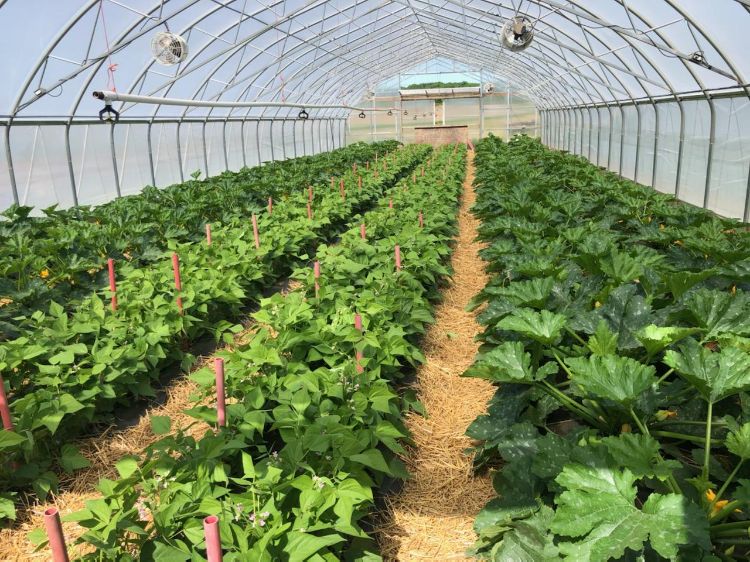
[466,137,750,562]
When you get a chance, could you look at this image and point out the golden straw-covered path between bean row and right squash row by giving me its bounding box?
[378,153,495,562]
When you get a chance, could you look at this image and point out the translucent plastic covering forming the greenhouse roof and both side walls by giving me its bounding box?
[0,0,750,220]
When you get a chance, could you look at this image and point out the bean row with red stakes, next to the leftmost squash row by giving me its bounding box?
[0,142,427,516]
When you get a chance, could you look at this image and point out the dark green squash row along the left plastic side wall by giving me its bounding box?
[0,141,397,340]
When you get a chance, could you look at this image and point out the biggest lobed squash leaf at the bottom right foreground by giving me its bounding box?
[550,465,709,562]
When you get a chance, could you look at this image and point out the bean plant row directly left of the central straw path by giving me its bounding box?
[32,146,465,562]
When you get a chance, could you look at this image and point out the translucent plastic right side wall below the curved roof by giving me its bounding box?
[540,95,750,222]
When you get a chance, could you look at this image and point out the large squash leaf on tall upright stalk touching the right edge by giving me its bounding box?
[664,340,750,402]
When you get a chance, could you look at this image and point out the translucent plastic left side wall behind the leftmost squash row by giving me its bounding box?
[0,118,346,213]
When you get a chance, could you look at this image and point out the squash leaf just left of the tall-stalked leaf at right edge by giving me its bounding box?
[566,355,657,407]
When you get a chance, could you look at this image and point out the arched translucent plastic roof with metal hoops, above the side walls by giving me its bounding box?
[0,0,750,124]
